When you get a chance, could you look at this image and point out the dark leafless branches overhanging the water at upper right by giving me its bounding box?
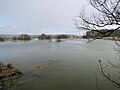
[74,0,120,40]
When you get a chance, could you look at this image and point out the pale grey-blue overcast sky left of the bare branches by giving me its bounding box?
[0,0,87,34]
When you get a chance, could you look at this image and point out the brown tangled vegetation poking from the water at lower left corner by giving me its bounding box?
[0,63,23,90]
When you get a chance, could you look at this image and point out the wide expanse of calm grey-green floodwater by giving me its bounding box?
[0,39,119,90]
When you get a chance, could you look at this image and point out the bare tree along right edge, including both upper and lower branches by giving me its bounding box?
[74,0,120,88]
